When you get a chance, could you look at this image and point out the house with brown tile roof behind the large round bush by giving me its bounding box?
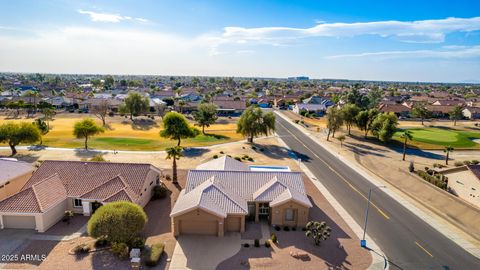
[0,160,161,232]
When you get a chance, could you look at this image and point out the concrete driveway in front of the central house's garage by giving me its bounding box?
[169,233,241,270]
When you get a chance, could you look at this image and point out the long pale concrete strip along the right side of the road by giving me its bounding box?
[275,112,480,258]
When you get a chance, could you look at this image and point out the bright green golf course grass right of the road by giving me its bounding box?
[393,127,480,149]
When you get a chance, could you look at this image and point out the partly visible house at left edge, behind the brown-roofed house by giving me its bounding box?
[0,159,34,201]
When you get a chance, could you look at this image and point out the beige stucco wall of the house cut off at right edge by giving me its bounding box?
[444,169,480,208]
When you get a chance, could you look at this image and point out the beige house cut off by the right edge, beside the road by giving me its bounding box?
[440,165,480,207]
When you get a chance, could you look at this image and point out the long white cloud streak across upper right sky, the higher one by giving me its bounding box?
[222,17,480,43]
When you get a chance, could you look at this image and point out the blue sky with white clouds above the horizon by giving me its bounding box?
[0,0,480,82]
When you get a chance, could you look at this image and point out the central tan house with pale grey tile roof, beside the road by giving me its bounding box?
[170,156,312,236]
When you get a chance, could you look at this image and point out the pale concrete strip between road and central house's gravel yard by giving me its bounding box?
[277,132,389,270]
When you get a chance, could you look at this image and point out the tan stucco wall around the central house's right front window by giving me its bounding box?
[270,201,309,227]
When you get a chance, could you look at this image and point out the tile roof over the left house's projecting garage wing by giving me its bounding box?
[0,174,67,213]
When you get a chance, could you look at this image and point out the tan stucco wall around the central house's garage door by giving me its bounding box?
[172,209,224,236]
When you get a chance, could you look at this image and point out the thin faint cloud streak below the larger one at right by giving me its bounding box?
[325,46,480,59]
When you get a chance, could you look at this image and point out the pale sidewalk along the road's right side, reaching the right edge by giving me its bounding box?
[276,111,480,258]
